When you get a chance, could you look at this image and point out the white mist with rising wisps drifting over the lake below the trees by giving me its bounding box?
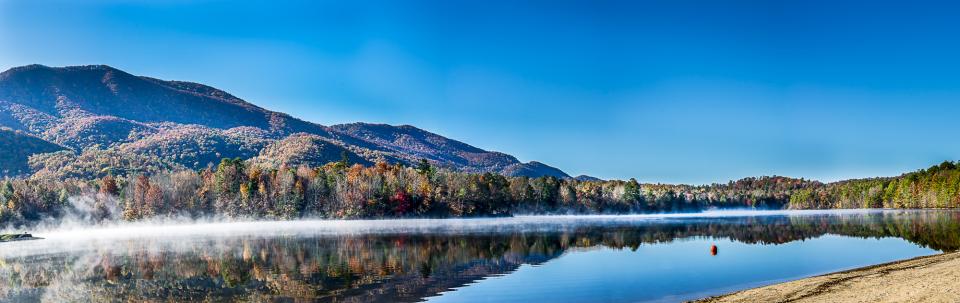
[7,207,896,254]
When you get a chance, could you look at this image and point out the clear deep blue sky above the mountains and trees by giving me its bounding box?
[0,0,960,183]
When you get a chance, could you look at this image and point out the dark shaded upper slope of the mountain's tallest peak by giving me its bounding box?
[0,65,324,133]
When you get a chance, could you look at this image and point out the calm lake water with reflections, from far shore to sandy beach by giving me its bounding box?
[0,211,960,302]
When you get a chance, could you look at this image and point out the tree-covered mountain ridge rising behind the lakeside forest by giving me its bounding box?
[0,65,569,178]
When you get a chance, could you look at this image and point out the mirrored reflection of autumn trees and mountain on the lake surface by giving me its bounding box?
[0,211,960,302]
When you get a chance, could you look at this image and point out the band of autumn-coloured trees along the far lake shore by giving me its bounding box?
[0,157,960,226]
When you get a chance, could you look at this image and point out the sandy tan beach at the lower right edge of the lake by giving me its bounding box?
[690,252,960,303]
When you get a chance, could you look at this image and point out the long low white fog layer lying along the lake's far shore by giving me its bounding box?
[0,210,922,258]
